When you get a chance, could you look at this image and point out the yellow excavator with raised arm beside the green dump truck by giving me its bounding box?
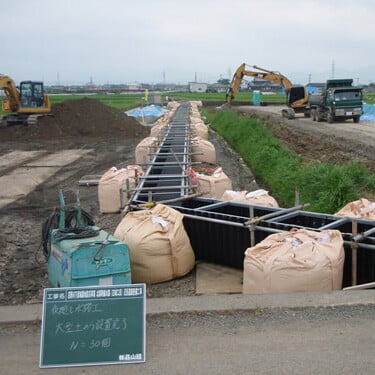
[226,63,310,119]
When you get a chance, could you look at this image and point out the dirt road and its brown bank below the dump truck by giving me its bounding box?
[235,106,375,172]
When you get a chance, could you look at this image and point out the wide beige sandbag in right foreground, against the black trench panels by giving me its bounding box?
[243,229,345,294]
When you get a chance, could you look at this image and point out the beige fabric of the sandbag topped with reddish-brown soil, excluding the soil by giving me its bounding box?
[194,167,232,199]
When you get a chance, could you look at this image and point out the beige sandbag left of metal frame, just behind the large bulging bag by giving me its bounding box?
[98,165,143,213]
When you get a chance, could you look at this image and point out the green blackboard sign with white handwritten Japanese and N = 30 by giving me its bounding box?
[39,284,146,368]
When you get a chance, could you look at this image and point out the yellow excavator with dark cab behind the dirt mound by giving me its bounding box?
[0,75,51,126]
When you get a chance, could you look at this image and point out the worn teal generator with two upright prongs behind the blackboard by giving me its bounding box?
[47,191,131,287]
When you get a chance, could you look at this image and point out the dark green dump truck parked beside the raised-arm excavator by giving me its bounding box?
[309,79,363,123]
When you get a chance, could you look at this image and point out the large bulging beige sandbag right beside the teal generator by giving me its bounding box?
[114,204,195,284]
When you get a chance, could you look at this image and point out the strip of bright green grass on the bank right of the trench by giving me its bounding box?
[204,110,375,214]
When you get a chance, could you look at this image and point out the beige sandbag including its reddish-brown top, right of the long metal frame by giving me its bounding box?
[191,166,232,199]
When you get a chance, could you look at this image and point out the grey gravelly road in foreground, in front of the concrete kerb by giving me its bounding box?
[0,305,375,375]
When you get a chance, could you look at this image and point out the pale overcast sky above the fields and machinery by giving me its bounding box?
[0,0,375,84]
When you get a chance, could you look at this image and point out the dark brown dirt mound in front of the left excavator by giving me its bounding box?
[1,98,149,143]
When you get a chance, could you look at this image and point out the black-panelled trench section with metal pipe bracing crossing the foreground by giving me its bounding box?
[175,198,375,287]
